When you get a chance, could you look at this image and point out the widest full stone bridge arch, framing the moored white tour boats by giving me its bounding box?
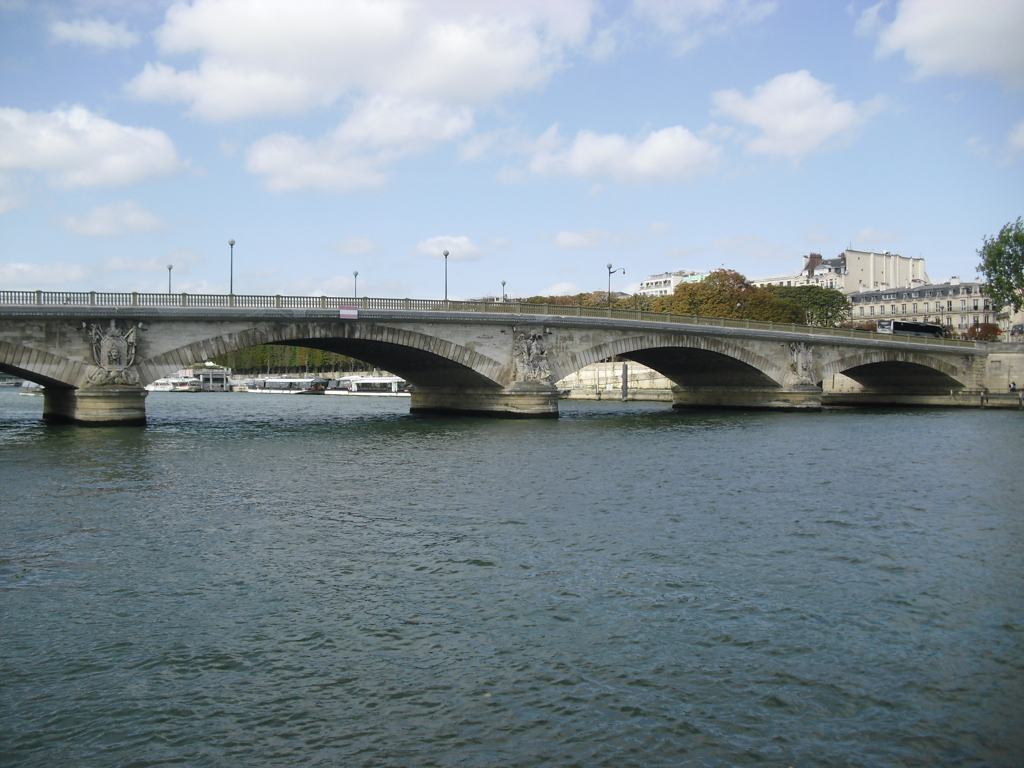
[139,323,507,389]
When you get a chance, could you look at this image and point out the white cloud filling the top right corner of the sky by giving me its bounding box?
[877,0,1024,88]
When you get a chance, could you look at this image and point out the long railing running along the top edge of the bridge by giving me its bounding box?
[0,291,975,347]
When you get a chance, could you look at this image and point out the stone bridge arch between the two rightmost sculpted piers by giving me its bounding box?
[552,333,793,388]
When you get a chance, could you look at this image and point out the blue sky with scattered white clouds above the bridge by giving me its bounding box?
[0,0,1024,298]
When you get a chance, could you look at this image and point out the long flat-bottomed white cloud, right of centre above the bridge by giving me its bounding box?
[529,125,721,182]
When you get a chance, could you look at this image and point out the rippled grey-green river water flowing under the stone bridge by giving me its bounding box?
[0,391,1024,768]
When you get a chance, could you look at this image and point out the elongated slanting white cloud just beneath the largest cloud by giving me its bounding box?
[246,96,473,191]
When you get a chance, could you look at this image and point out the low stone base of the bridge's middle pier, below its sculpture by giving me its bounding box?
[409,381,558,419]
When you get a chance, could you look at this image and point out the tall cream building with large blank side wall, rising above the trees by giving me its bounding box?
[751,248,931,294]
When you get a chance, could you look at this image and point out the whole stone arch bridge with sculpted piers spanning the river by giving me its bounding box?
[0,292,1006,424]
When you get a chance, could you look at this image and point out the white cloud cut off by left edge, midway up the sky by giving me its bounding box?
[0,106,181,188]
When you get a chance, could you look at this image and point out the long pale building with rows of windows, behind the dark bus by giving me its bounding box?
[850,278,995,331]
